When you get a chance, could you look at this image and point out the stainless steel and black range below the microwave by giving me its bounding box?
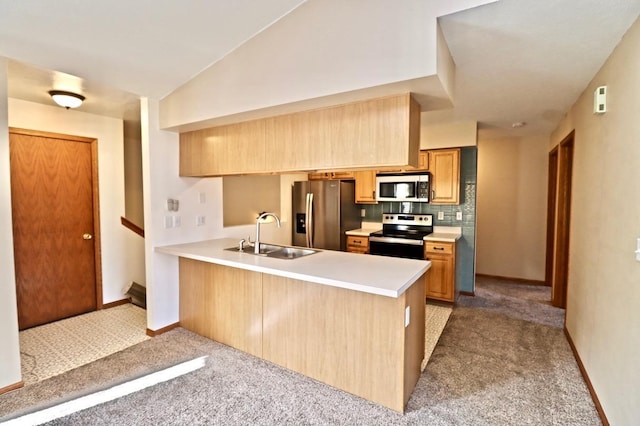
[369,213,433,259]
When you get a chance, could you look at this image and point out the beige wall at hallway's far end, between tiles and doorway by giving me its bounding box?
[476,137,548,281]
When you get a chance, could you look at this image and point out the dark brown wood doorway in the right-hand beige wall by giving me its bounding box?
[545,132,574,309]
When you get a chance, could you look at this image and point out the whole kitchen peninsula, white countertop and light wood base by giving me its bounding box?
[155,239,431,412]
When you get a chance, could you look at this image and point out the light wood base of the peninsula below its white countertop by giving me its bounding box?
[180,258,425,413]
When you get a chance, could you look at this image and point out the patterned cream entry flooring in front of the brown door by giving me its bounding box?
[20,303,149,385]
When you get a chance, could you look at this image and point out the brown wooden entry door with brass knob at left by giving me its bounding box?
[9,129,101,329]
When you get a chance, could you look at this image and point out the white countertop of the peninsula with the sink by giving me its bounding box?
[155,238,431,297]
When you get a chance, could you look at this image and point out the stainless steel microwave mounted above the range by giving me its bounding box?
[376,173,429,203]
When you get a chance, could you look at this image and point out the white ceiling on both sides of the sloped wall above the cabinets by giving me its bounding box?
[0,0,640,137]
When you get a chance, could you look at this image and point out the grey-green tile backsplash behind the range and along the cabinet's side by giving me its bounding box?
[362,147,478,292]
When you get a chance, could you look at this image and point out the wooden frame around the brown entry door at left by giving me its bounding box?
[9,127,103,310]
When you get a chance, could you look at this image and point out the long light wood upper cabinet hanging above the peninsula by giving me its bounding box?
[180,93,420,176]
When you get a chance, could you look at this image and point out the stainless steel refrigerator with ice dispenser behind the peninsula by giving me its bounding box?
[291,180,360,251]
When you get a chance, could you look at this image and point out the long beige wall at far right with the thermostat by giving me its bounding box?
[551,16,640,425]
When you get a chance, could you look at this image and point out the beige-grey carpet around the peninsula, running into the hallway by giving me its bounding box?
[0,278,601,426]
